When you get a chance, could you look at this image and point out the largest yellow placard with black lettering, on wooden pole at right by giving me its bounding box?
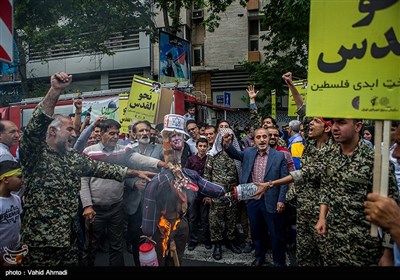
[307,0,400,120]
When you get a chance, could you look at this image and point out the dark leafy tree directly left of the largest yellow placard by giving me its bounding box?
[243,0,310,115]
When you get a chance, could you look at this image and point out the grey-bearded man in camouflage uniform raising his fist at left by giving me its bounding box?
[20,72,153,266]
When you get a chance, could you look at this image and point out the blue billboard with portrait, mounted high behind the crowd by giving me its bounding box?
[158,31,191,84]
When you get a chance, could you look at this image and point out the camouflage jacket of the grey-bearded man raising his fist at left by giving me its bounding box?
[19,104,127,247]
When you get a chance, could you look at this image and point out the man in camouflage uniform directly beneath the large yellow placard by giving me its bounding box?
[256,119,398,266]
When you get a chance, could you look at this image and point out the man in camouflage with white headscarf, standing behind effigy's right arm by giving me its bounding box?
[204,128,241,260]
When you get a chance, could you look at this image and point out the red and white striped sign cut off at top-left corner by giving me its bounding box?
[0,0,13,63]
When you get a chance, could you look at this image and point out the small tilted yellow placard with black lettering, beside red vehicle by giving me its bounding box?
[125,75,161,124]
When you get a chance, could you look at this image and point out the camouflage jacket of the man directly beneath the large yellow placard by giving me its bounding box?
[297,140,398,266]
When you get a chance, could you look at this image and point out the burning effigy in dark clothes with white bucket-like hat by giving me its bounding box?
[142,114,225,266]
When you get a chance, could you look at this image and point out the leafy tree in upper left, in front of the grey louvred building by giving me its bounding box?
[14,0,156,98]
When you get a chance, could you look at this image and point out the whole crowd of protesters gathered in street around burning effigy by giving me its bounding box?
[0,72,400,266]
